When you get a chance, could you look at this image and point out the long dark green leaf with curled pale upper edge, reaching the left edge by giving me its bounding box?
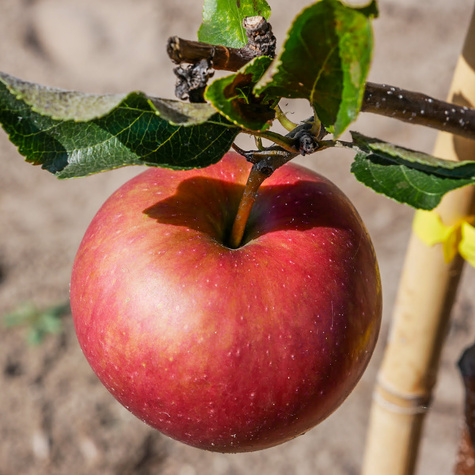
[0,73,239,178]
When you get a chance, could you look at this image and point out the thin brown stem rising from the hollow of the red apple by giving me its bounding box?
[229,164,269,249]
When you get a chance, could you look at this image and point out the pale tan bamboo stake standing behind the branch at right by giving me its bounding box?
[362,6,475,475]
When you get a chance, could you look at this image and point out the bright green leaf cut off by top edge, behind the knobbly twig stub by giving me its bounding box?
[198,0,270,48]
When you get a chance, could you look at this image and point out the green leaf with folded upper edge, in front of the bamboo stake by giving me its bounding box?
[351,132,475,210]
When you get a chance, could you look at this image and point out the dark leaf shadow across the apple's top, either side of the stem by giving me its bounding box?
[143,177,353,241]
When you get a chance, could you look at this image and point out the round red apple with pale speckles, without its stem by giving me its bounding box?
[71,152,381,452]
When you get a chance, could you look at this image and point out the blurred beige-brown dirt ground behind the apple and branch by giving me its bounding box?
[0,0,475,475]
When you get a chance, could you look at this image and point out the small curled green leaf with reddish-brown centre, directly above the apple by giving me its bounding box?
[205,56,275,131]
